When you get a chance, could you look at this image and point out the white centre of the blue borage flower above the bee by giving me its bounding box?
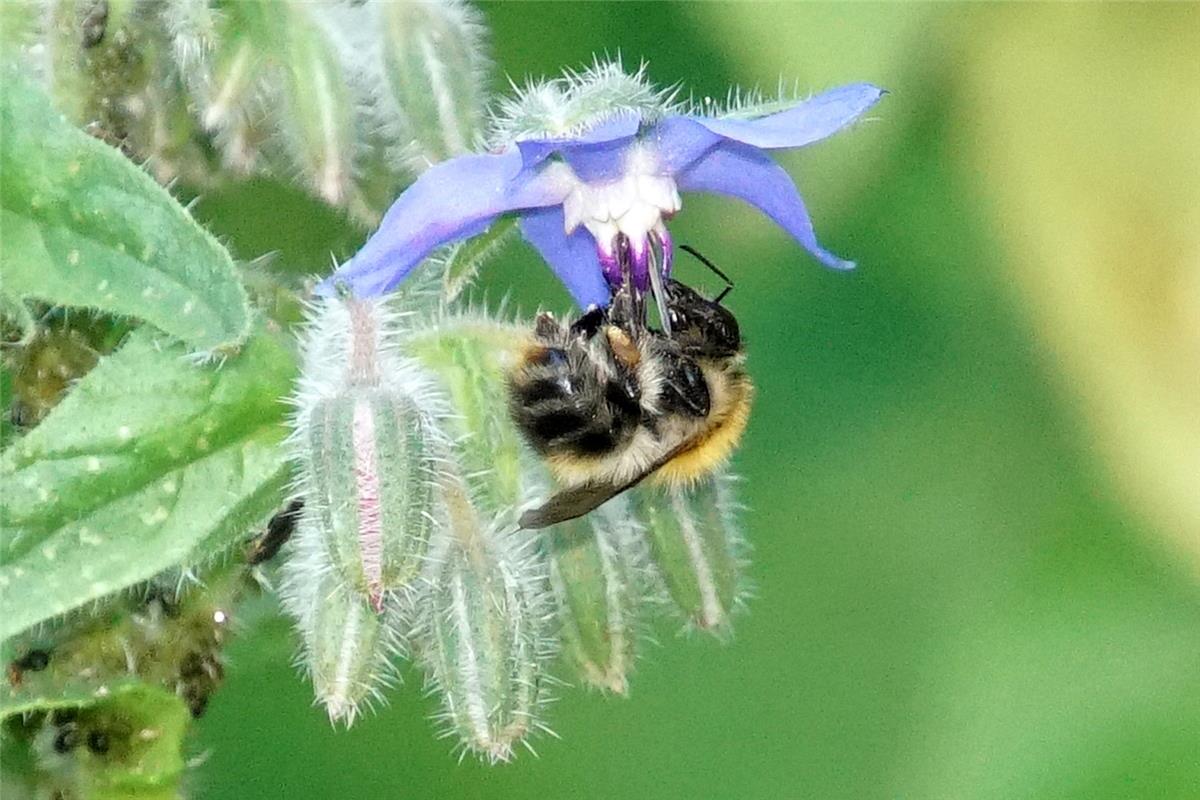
[563,148,682,249]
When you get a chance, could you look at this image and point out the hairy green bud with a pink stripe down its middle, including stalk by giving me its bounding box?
[292,299,449,613]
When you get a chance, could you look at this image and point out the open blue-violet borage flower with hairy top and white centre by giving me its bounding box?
[319,65,883,308]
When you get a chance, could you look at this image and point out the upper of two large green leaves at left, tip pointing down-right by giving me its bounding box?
[0,68,250,350]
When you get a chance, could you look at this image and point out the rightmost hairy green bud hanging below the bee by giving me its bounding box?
[631,473,746,636]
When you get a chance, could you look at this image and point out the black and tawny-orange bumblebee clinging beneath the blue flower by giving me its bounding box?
[509,249,754,528]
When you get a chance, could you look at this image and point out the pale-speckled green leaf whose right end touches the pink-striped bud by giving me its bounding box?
[0,321,294,639]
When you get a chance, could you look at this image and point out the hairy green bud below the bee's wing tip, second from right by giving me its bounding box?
[545,498,648,694]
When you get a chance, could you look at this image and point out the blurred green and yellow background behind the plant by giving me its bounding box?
[191,2,1200,800]
